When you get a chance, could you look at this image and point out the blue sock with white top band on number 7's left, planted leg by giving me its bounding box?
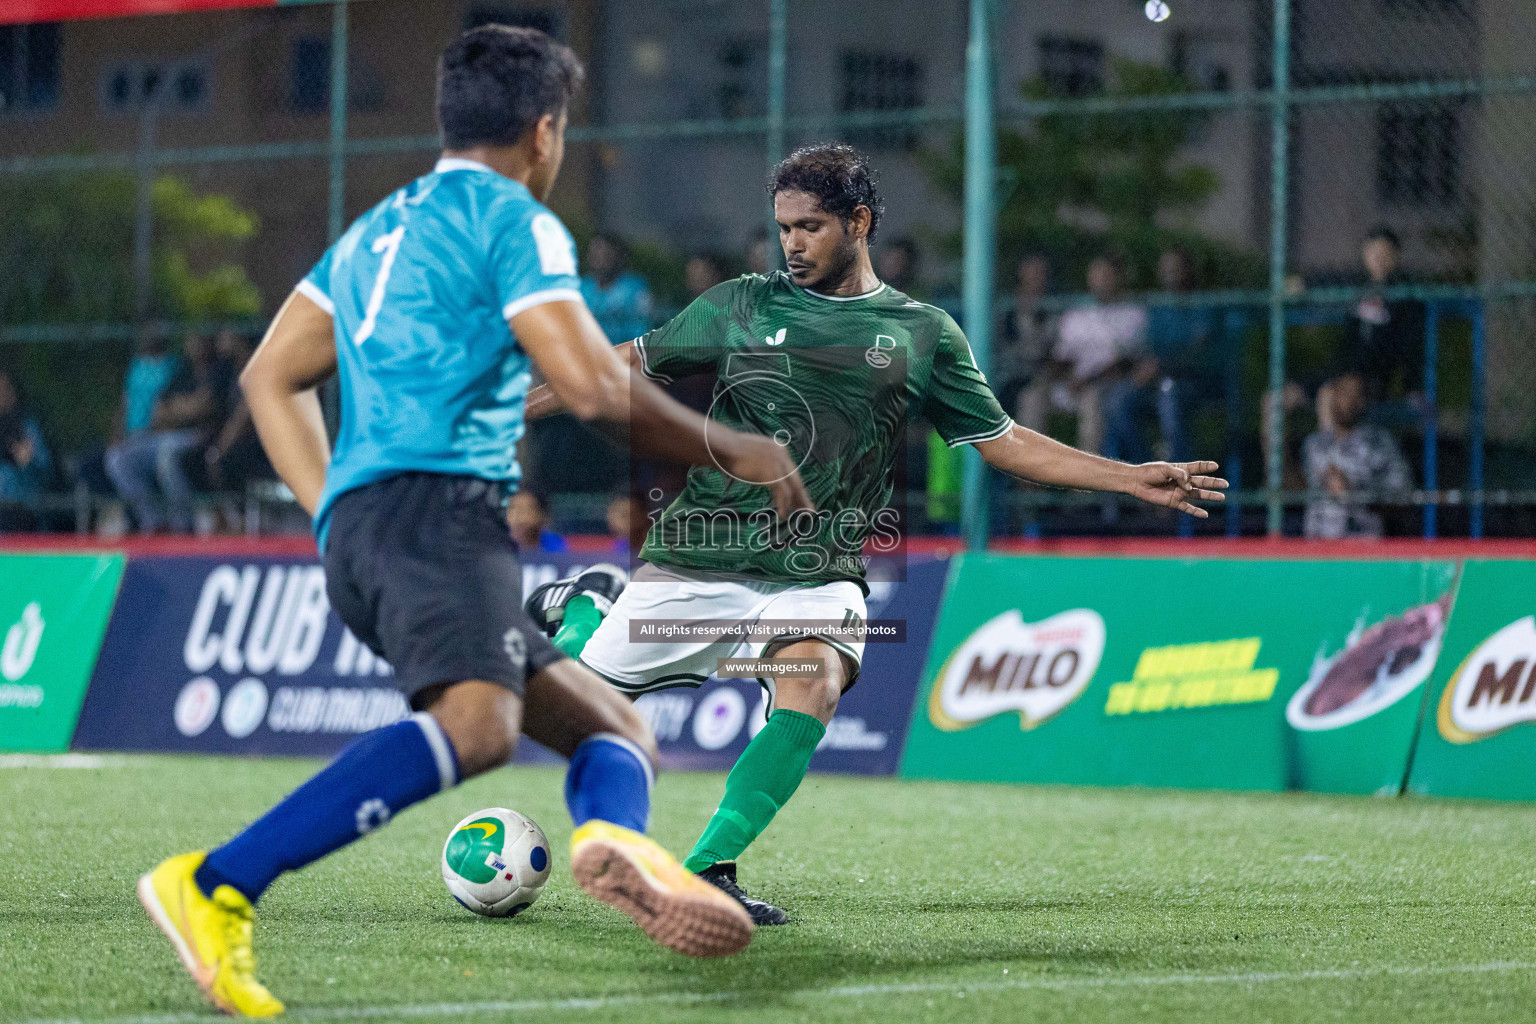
[197,714,459,903]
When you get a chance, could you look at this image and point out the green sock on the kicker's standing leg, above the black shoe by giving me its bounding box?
[684,708,826,872]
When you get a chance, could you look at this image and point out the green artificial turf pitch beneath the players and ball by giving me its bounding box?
[0,757,1536,1024]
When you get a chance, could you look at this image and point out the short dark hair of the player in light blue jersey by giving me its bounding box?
[438,25,587,149]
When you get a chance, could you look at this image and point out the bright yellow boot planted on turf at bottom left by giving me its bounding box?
[138,851,283,1016]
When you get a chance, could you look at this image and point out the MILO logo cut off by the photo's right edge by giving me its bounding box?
[1438,616,1536,743]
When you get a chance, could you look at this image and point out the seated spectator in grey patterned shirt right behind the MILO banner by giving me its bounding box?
[1303,372,1410,539]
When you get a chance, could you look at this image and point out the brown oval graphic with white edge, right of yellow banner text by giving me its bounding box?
[1286,594,1450,732]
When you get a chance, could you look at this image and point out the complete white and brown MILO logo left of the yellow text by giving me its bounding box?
[928,608,1104,731]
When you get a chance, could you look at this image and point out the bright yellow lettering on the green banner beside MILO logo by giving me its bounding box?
[1104,637,1279,715]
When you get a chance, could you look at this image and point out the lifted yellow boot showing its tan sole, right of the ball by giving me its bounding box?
[571,820,753,956]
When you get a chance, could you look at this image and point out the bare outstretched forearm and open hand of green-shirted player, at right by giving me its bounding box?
[975,425,1227,519]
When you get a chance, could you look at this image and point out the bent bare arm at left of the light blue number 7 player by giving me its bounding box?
[240,292,336,516]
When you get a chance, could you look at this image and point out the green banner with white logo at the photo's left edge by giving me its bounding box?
[0,554,124,751]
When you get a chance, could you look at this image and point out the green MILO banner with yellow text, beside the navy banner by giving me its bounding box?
[902,554,1458,792]
